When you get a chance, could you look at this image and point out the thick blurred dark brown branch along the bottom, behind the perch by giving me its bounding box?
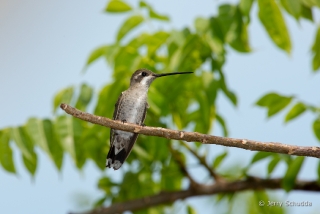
[74,177,320,214]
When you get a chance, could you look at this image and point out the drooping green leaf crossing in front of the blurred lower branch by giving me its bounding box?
[281,157,304,192]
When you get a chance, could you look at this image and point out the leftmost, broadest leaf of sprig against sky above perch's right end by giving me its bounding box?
[256,93,292,117]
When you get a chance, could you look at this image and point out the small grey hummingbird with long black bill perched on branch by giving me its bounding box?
[106,69,193,170]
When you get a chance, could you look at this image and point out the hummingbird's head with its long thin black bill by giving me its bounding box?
[130,68,193,88]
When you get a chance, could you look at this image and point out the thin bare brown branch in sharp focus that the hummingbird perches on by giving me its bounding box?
[60,103,320,158]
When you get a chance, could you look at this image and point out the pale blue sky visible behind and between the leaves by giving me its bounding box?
[0,0,320,214]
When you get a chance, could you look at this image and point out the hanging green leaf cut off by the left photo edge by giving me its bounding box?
[0,129,16,173]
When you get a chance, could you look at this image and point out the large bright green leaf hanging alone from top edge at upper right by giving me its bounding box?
[258,0,291,53]
